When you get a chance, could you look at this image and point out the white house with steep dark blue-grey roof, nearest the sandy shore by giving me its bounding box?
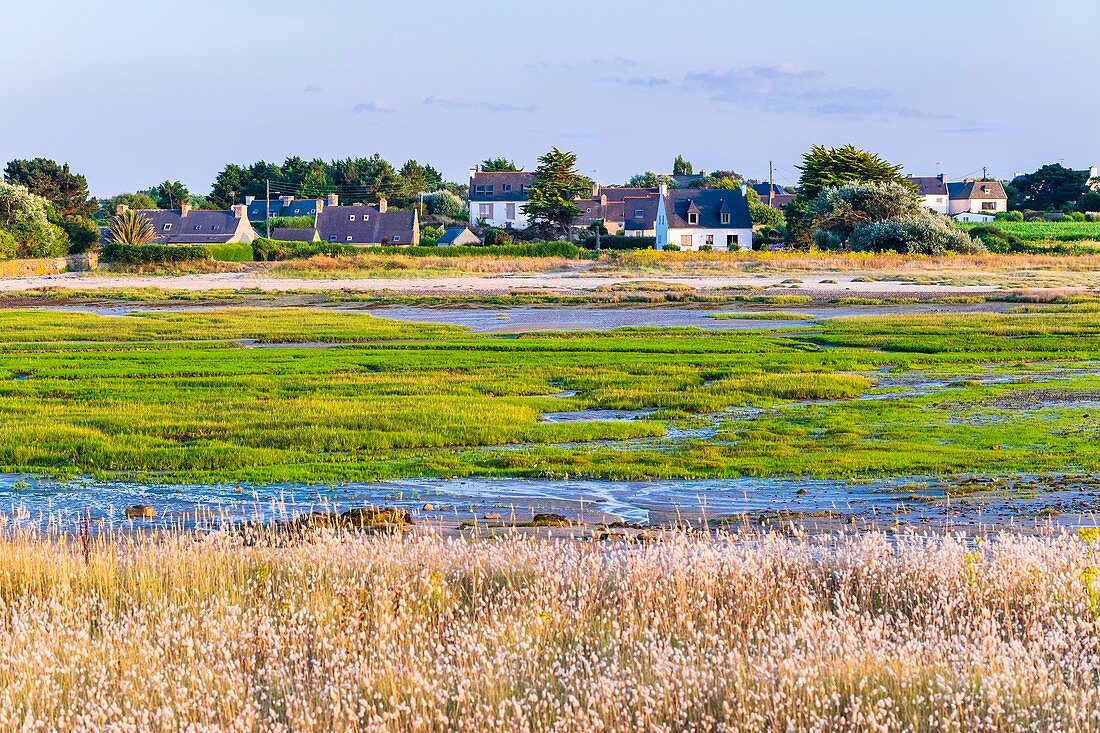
[656,185,752,251]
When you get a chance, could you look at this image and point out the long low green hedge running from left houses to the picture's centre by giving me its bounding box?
[252,238,581,262]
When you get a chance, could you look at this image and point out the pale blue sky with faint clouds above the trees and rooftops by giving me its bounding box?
[0,0,1100,197]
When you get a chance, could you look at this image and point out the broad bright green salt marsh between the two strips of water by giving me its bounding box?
[0,308,1100,482]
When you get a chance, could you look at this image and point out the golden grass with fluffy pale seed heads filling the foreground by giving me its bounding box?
[0,533,1100,732]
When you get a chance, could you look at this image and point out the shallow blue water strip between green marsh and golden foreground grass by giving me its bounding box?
[0,475,1100,532]
